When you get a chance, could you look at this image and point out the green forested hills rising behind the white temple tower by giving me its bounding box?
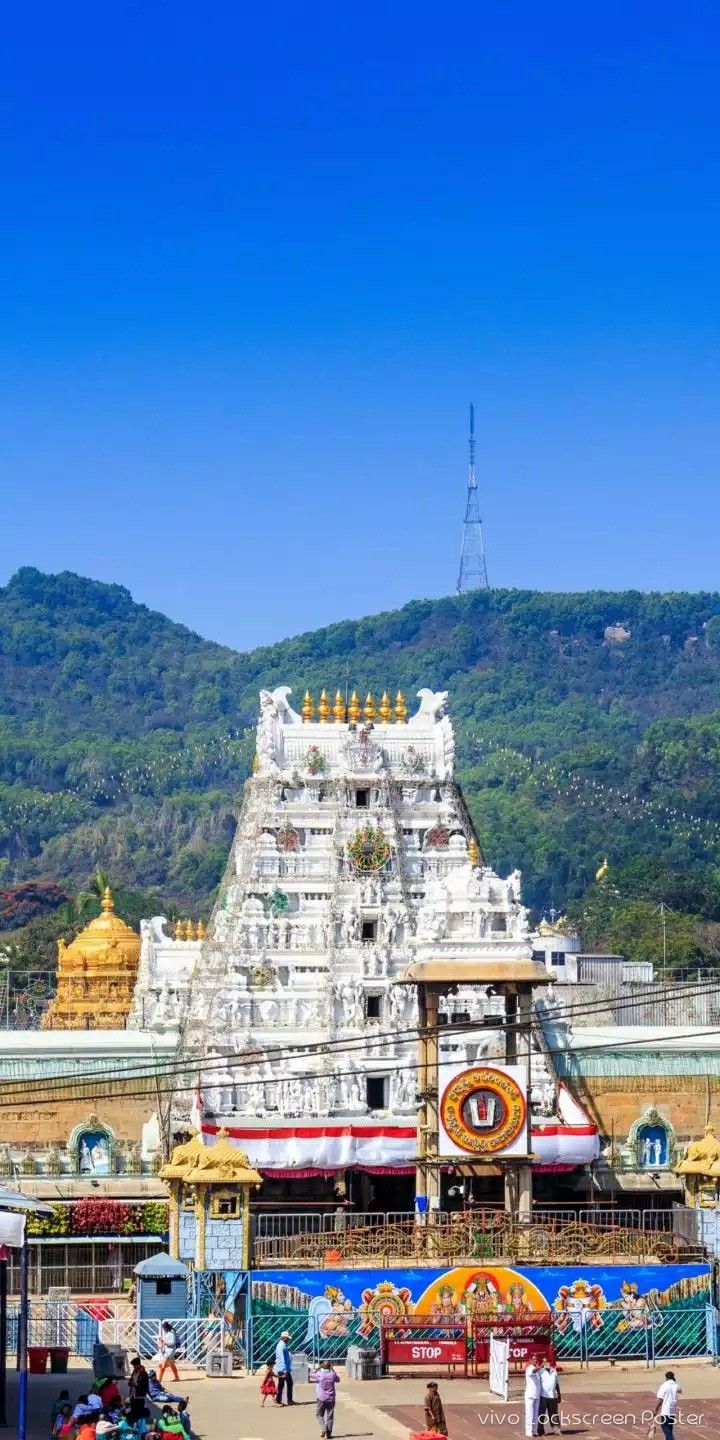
[0,569,720,958]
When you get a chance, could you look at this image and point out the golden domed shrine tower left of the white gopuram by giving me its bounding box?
[42,886,140,1030]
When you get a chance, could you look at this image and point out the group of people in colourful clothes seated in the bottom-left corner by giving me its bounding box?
[50,1355,193,1440]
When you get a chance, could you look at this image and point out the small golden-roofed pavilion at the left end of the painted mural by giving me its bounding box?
[160,1130,262,1272]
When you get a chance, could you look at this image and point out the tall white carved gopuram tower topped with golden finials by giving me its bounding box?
[168,687,596,1198]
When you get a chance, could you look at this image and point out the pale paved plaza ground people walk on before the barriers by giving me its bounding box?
[7,1362,720,1440]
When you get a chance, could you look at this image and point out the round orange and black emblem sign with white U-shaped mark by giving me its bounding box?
[439,1066,527,1155]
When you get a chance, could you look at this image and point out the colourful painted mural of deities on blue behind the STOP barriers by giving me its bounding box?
[251,1264,711,1355]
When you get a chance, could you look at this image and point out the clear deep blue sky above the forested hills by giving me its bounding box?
[0,0,720,647]
